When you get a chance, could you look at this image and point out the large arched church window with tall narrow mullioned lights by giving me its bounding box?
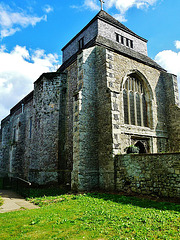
[123,74,148,127]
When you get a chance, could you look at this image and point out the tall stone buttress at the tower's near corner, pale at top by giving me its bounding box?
[72,47,99,190]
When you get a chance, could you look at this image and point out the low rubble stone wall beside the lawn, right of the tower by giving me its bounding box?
[115,153,180,198]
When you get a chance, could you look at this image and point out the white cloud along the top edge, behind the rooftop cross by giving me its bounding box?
[81,0,158,22]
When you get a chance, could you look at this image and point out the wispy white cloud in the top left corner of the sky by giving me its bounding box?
[0,3,47,39]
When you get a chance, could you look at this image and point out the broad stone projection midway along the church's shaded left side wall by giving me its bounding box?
[29,73,66,185]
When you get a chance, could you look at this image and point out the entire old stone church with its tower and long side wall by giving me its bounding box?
[0,10,180,190]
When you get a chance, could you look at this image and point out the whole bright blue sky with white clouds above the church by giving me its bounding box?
[0,0,180,120]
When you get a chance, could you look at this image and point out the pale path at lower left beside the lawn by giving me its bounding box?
[0,190,39,213]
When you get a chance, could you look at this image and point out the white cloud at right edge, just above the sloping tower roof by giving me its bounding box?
[155,41,180,93]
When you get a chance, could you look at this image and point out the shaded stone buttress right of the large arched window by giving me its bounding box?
[155,72,180,152]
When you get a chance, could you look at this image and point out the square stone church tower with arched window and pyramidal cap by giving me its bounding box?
[59,10,179,190]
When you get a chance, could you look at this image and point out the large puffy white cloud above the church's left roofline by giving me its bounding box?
[0,45,57,120]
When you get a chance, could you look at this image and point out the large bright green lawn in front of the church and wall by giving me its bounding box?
[0,193,180,240]
